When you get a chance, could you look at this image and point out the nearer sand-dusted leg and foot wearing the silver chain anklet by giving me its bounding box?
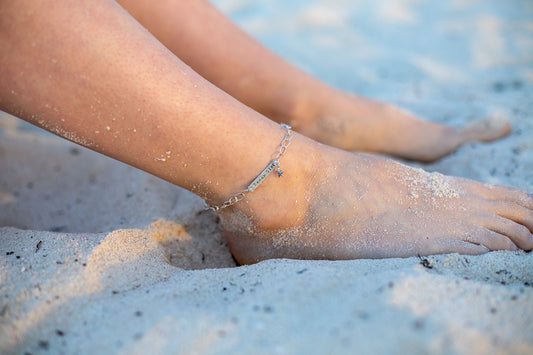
[0,0,533,262]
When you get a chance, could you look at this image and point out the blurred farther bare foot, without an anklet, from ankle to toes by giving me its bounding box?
[291,89,511,162]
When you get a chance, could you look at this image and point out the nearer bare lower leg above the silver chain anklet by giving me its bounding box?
[0,0,282,209]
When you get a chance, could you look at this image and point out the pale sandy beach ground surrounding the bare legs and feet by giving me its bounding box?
[0,0,533,354]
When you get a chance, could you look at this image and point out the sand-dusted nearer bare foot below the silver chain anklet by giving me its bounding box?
[218,136,533,263]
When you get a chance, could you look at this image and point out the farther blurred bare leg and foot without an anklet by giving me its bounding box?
[119,0,510,161]
